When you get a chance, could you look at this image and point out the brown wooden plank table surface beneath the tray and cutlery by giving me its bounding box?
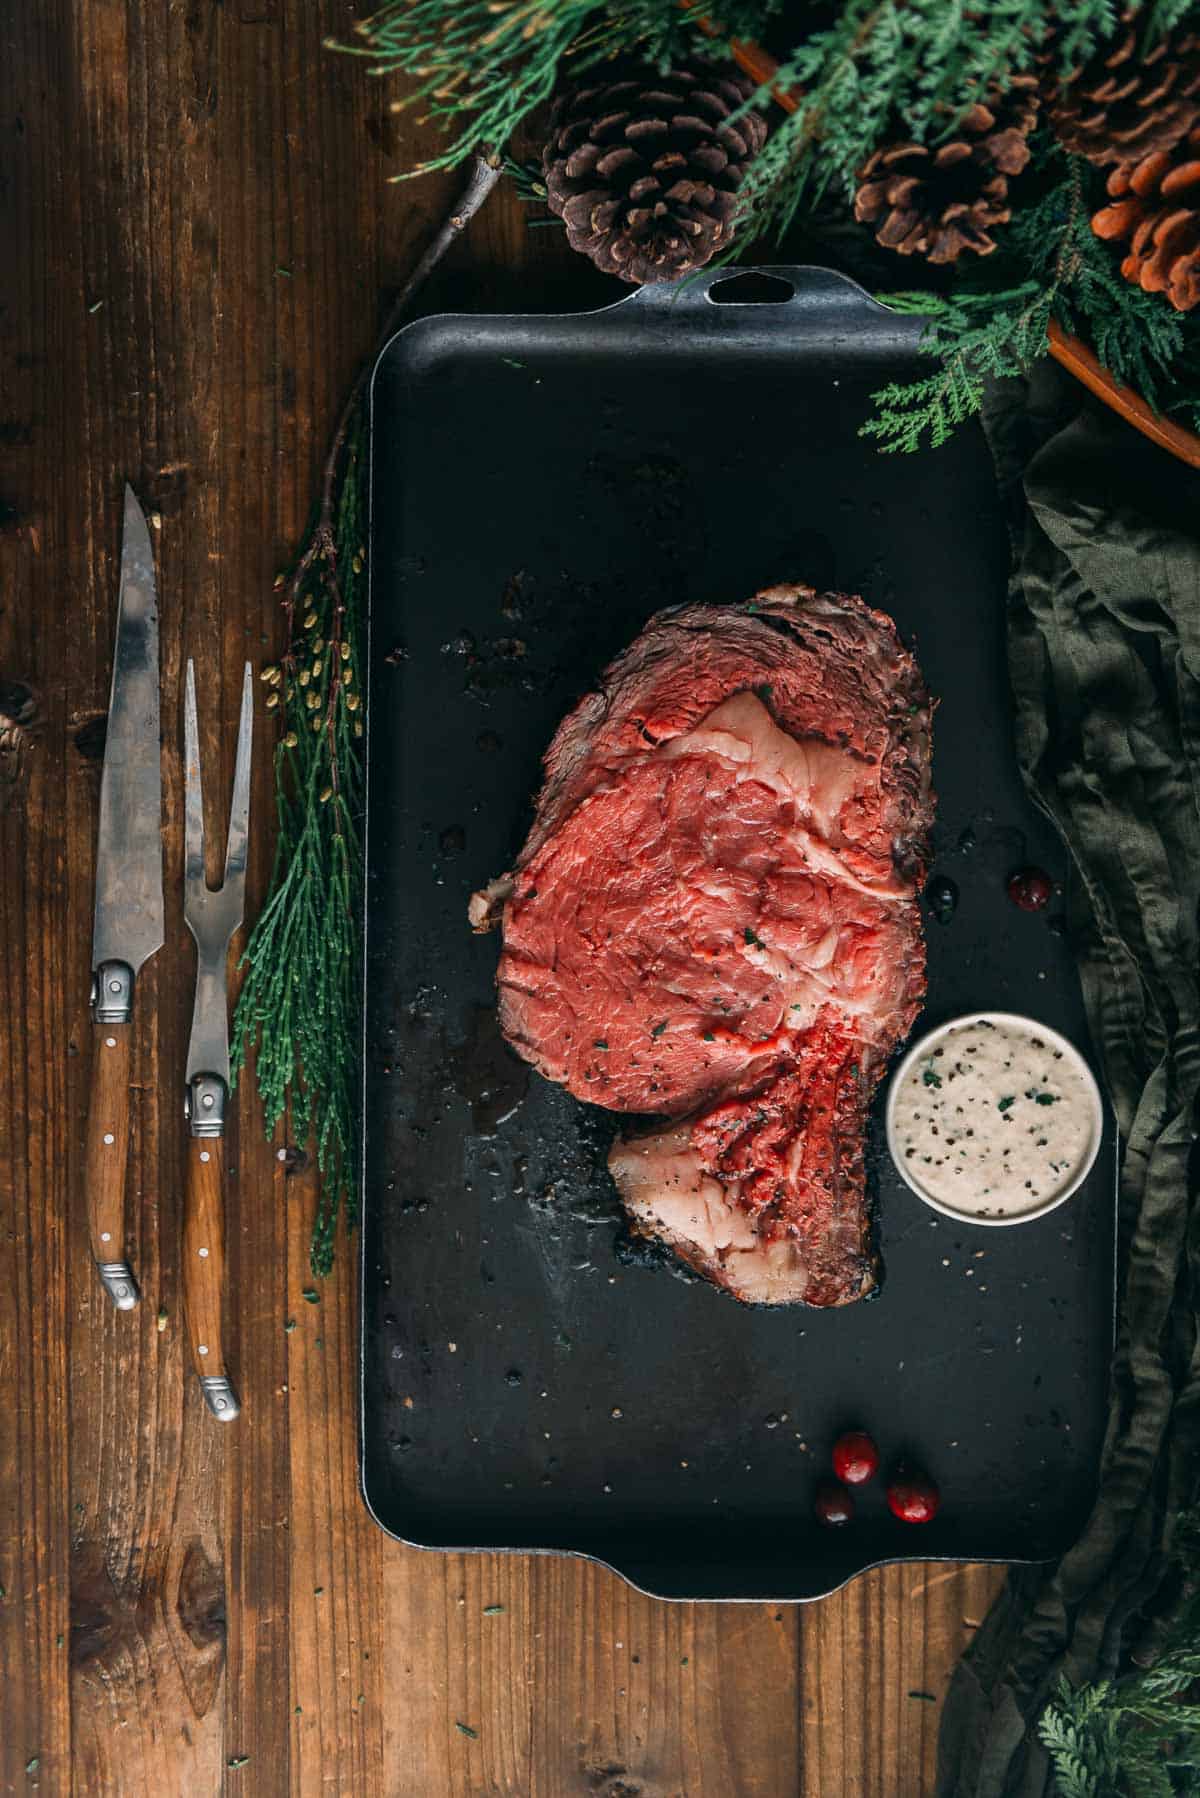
[0,0,1000,1798]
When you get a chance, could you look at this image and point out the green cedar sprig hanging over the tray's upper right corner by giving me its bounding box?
[862,137,1200,451]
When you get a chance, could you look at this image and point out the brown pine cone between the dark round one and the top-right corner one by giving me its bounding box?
[855,76,1038,263]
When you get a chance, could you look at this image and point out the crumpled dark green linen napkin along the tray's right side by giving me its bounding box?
[937,363,1200,1798]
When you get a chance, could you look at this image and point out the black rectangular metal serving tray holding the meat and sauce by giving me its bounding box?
[362,268,1115,1598]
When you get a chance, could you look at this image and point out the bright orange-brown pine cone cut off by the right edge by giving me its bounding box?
[1092,126,1200,313]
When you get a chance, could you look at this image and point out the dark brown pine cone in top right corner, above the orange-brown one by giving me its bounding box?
[1045,9,1200,167]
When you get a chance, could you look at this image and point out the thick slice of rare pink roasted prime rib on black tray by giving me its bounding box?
[471,586,932,1305]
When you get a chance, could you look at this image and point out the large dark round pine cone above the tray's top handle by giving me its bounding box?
[543,61,766,284]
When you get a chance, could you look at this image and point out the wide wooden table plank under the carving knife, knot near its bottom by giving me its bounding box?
[57,0,227,1793]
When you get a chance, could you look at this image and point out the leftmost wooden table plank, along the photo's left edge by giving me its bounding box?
[0,7,70,1791]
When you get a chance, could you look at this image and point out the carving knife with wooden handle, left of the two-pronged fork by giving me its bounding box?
[86,485,164,1311]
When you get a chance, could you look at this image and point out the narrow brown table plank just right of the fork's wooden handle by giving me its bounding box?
[201,0,300,1794]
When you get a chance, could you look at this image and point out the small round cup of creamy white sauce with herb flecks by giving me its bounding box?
[892,1021,1096,1217]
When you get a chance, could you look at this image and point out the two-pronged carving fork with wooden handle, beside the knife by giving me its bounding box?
[184,660,254,1422]
